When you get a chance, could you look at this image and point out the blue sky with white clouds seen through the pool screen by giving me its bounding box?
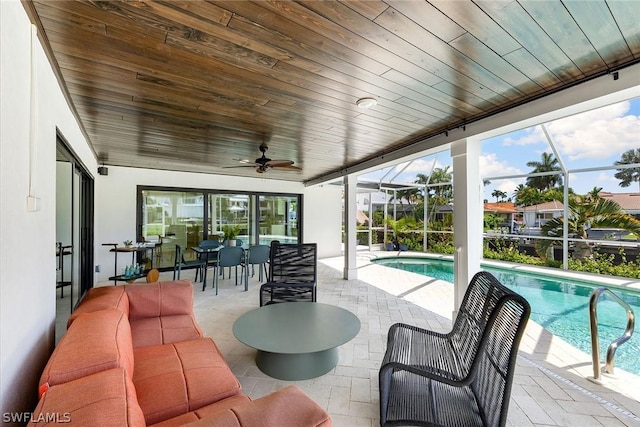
[361,98,640,201]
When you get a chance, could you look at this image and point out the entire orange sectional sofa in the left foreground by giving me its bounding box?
[30,280,331,427]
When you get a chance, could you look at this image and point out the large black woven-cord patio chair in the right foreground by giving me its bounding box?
[379,272,531,427]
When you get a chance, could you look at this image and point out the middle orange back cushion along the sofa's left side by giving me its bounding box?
[40,309,134,392]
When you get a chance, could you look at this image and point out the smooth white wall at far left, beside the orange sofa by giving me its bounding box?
[0,0,96,422]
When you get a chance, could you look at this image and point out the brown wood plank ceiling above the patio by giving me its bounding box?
[24,0,640,181]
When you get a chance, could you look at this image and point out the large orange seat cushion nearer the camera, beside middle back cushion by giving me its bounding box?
[133,338,240,424]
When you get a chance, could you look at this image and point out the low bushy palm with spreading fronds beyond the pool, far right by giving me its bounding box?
[536,195,640,259]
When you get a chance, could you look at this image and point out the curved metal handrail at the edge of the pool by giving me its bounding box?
[589,287,635,380]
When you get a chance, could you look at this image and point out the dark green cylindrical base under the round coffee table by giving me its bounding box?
[256,348,339,381]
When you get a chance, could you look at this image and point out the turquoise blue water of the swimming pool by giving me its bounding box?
[374,257,640,375]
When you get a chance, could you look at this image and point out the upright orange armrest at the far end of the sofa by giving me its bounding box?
[125,280,193,320]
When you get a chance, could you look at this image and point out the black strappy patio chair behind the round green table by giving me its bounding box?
[260,242,318,307]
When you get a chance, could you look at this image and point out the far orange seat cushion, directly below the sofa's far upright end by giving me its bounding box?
[130,314,202,348]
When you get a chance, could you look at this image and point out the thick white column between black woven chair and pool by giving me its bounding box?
[451,138,483,319]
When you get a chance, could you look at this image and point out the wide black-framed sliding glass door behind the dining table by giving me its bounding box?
[137,186,302,269]
